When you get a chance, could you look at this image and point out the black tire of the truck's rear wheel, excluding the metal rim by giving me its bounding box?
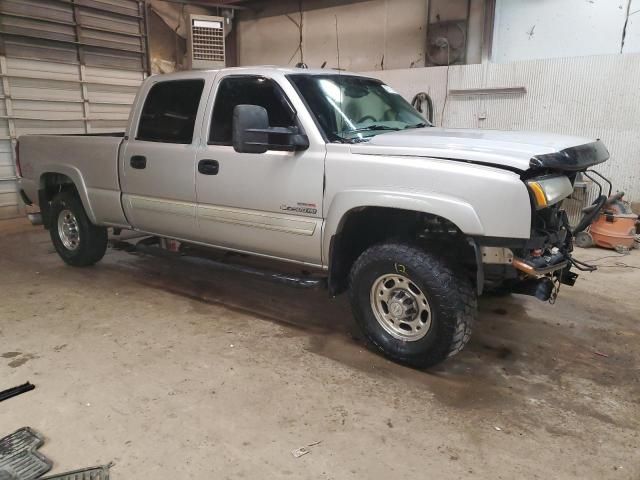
[49,192,108,267]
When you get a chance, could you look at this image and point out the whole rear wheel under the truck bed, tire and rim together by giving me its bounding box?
[49,192,108,267]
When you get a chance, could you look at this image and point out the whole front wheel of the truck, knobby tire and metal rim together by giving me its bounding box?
[350,243,477,368]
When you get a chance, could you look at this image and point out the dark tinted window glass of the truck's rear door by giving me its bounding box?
[136,80,204,144]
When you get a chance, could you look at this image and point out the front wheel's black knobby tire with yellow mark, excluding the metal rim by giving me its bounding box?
[349,243,477,368]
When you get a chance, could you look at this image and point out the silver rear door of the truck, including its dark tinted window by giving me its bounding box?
[120,78,206,239]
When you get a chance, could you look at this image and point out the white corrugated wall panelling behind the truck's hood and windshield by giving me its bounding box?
[368,54,640,201]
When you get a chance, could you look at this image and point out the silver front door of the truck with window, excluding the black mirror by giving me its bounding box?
[196,74,326,265]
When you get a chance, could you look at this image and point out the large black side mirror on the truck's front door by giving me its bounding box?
[233,105,309,153]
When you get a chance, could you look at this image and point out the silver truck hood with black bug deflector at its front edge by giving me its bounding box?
[352,127,609,171]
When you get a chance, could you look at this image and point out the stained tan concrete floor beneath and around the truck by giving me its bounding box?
[0,220,640,480]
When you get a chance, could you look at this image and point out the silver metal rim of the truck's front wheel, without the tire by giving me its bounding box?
[371,273,431,342]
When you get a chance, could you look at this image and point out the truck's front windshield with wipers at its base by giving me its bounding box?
[288,74,428,143]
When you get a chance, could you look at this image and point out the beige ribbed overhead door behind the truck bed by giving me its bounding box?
[0,0,147,218]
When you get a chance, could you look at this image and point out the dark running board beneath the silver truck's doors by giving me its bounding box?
[111,237,327,289]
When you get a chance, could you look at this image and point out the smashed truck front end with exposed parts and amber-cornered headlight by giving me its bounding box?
[481,141,612,303]
